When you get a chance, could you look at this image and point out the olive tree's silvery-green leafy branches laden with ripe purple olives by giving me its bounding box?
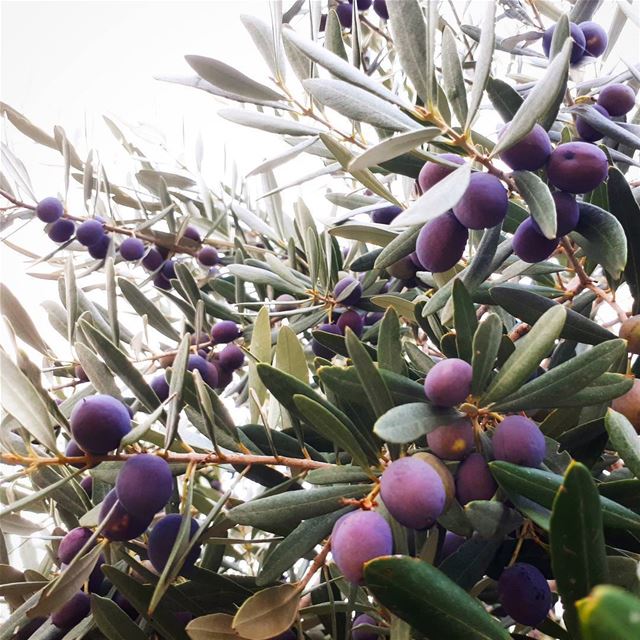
[0,0,640,640]
